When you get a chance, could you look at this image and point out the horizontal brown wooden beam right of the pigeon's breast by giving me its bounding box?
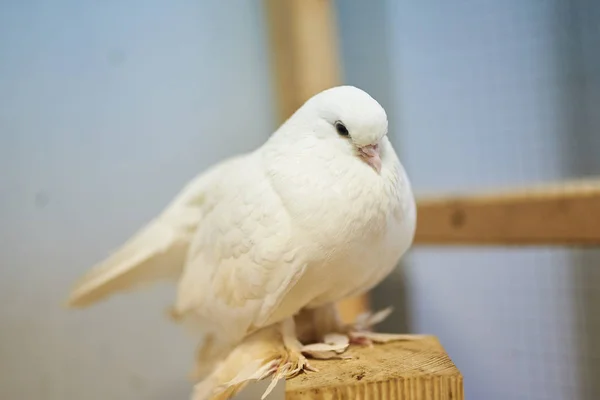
[415,179,600,246]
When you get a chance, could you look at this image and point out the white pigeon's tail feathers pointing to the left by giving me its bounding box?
[67,219,189,307]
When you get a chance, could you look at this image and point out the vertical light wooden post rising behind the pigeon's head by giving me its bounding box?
[264,0,369,322]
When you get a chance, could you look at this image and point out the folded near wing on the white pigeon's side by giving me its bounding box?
[174,158,305,342]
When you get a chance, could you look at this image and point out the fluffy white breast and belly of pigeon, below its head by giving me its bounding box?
[264,139,416,318]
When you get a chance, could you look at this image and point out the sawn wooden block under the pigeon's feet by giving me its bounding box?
[285,335,464,400]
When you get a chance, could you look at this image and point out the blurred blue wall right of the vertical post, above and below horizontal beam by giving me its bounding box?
[338,0,600,400]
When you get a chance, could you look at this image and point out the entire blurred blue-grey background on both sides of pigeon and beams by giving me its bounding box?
[0,0,600,400]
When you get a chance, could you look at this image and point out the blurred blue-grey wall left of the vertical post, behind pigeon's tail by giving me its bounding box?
[0,0,275,400]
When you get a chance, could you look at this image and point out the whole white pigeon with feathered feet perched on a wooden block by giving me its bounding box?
[64,86,416,400]
